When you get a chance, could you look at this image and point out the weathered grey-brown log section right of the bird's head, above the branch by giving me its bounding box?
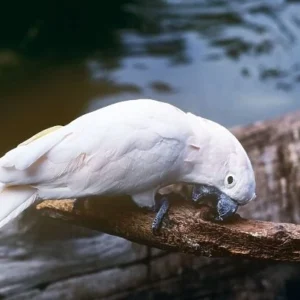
[232,111,300,224]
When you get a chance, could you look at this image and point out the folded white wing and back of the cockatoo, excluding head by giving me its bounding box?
[0,100,190,199]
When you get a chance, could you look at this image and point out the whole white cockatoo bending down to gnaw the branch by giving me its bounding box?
[0,99,255,229]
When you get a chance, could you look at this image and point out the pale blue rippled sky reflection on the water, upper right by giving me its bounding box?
[89,1,300,126]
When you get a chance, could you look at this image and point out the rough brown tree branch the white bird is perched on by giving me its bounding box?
[37,197,300,261]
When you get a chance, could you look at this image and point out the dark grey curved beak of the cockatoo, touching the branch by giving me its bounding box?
[192,185,239,221]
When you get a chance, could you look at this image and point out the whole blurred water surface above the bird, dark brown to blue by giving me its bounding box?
[0,0,300,237]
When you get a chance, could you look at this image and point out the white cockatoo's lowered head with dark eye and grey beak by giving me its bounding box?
[187,114,256,219]
